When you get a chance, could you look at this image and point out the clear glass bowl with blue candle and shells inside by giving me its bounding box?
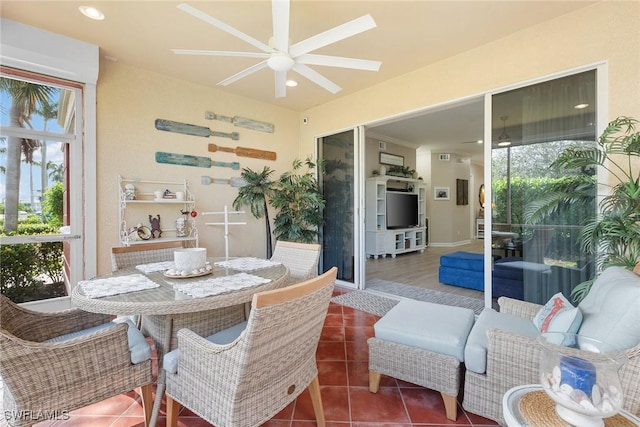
[538,332,627,427]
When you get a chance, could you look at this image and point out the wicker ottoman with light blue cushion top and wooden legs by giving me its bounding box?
[367,300,475,420]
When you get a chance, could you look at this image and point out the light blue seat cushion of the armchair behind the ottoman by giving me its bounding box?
[464,308,540,374]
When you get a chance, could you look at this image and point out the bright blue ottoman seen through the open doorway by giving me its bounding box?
[438,251,484,291]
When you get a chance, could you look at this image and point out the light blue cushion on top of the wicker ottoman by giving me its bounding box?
[373,300,475,362]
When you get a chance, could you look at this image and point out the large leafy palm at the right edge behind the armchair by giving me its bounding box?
[532,116,640,300]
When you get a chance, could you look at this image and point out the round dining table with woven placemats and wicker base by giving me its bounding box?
[71,258,289,426]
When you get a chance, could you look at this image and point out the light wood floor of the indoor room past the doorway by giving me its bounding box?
[365,239,484,298]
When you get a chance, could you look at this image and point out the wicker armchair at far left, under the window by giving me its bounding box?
[0,295,153,427]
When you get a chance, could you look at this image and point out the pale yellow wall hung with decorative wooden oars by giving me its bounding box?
[97,61,299,273]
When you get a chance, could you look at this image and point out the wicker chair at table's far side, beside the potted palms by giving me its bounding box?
[271,240,321,284]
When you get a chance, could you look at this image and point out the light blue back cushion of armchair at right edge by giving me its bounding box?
[578,267,640,349]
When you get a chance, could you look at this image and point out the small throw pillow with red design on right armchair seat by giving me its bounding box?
[533,292,582,334]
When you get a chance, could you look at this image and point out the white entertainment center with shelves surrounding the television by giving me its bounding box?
[365,176,428,259]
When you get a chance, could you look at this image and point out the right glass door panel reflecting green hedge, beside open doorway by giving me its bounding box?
[490,70,597,303]
